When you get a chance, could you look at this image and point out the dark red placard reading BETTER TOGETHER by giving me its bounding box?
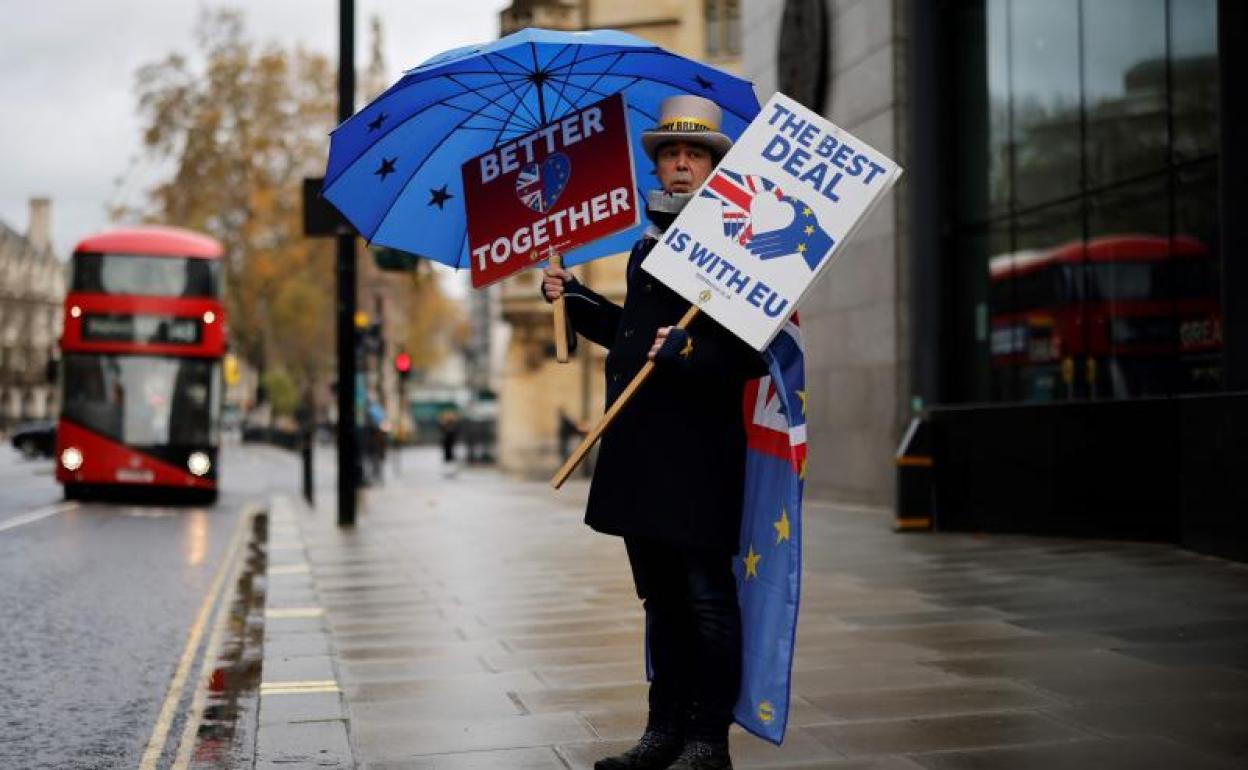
[462,94,638,288]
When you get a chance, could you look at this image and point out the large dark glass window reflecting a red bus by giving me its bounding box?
[947,0,1222,402]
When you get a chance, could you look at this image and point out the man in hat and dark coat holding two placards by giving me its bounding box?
[543,95,768,770]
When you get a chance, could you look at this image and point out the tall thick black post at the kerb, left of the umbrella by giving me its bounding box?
[336,0,359,527]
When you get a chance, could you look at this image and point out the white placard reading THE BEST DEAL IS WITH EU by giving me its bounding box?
[641,94,901,351]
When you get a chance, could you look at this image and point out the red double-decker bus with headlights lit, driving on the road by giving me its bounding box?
[56,227,226,502]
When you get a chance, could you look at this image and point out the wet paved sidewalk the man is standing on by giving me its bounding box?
[256,451,1248,770]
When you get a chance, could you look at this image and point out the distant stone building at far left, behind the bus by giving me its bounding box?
[0,198,66,428]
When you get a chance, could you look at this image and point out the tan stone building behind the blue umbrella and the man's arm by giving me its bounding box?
[498,0,741,477]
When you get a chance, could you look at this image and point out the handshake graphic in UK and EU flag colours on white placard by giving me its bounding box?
[701,170,836,271]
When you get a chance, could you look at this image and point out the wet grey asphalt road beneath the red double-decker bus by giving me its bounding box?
[0,446,298,769]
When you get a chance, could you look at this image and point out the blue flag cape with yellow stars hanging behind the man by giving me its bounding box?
[734,316,806,744]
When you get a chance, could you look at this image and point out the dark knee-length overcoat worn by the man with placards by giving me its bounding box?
[564,238,766,554]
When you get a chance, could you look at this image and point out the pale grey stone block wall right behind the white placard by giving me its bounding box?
[741,0,910,505]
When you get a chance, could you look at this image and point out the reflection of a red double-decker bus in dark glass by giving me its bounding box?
[988,235,1222,401]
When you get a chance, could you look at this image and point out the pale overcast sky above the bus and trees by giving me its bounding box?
[0,0,509,258]
